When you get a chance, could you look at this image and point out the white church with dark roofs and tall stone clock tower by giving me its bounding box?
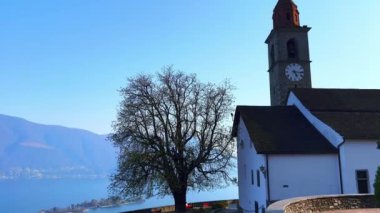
[232,0,380,213]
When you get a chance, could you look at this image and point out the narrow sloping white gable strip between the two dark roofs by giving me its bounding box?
[287,92,344,147]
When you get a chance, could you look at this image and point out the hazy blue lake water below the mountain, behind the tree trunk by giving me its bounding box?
[0,179,238,213]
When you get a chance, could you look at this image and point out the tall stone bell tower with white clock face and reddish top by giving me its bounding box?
[265,0,311,106]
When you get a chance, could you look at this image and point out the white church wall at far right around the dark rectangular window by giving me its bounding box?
[340,139,380,194]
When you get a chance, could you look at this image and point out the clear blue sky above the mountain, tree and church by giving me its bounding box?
[0,0,380,133]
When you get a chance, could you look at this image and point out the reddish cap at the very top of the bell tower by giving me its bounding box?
[273,0,300,29]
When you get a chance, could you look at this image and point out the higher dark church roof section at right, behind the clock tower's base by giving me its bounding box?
[292,89,380,139]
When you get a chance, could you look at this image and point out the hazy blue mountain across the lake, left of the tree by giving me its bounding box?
[0,115,117,179]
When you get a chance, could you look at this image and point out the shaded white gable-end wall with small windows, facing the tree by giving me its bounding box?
[237,119,267,212]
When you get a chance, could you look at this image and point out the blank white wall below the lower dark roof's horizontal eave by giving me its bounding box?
[268,154,340,200]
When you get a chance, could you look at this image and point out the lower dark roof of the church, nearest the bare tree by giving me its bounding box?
[232,106,337,154]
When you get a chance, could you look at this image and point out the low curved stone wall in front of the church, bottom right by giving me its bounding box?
[267,195,376,213]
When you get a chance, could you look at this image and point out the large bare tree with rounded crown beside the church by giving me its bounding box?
[110,67,234,212]
